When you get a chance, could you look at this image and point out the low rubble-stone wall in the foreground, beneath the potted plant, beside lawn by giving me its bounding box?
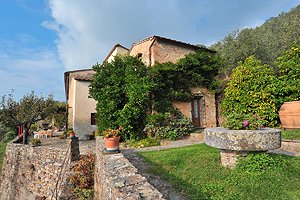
[94,137,163,200]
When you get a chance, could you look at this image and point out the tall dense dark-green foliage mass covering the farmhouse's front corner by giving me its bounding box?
[90,56,154,137]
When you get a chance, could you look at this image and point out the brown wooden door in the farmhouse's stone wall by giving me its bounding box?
[191,96,205,128]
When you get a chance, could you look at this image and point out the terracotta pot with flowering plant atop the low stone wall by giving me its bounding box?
[103,129,120,151]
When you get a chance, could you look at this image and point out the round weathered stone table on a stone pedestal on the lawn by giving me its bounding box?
[204,127,281,168]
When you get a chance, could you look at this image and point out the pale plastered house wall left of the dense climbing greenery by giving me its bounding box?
[73,80,97,139]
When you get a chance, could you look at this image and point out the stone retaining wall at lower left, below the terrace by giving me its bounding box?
[0,138,76,200]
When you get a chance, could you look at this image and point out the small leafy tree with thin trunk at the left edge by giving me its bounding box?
[0,92,56,144]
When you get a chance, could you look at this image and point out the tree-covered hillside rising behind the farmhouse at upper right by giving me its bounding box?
[210,5,300,74]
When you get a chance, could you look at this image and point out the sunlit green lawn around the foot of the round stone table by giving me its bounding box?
[140,144,300,200]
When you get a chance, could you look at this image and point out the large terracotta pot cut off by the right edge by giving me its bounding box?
[279,101,300,129]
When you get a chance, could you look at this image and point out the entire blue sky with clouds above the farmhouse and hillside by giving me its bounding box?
[0,0,300,101]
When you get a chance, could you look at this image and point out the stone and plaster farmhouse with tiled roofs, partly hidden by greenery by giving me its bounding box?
[64,36,217,139]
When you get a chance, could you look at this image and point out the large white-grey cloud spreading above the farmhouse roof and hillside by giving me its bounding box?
[43,0,297,70]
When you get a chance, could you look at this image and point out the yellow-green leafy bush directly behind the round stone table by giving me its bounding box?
[221,56,279,126]
